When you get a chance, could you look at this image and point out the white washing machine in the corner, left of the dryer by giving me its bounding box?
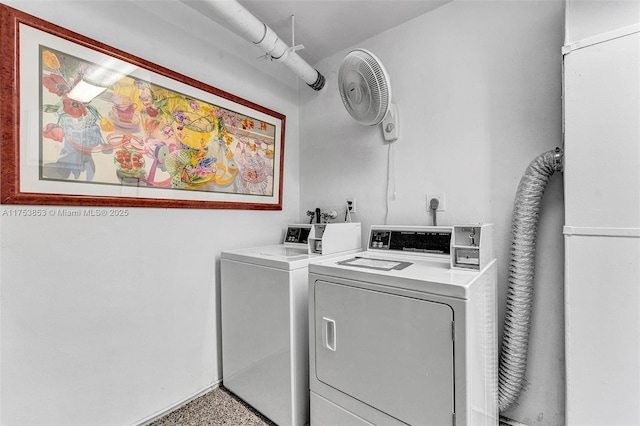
[220,223,362,426]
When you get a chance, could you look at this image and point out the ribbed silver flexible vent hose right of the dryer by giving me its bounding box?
[498,148,562,412]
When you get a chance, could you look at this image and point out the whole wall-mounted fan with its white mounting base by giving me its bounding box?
[338,49,398,142]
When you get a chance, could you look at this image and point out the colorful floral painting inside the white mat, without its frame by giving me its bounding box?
[40,46,275,196]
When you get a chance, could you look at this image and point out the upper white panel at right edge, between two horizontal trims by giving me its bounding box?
[564,33,640,228]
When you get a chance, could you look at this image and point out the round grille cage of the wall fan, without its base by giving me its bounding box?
[338,50,391,126]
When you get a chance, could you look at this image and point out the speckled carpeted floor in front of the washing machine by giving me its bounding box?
[149,386,275,426]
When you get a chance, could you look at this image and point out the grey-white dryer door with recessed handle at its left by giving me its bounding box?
[314,281,454,425]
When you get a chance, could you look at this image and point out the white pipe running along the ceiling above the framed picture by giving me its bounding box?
[195,0,325,90]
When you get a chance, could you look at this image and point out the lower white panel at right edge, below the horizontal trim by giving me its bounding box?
[565,235,640,426]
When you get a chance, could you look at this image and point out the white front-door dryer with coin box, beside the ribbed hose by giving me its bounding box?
[309,225,498,426]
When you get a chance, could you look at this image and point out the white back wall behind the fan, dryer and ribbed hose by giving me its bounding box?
[300,0,564,425]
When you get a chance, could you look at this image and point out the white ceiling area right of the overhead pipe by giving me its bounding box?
[189,0,452,64]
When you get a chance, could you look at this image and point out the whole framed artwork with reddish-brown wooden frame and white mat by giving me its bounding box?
[0,5,285,210]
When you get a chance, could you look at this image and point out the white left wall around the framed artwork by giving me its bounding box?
[0,1,300,426]
